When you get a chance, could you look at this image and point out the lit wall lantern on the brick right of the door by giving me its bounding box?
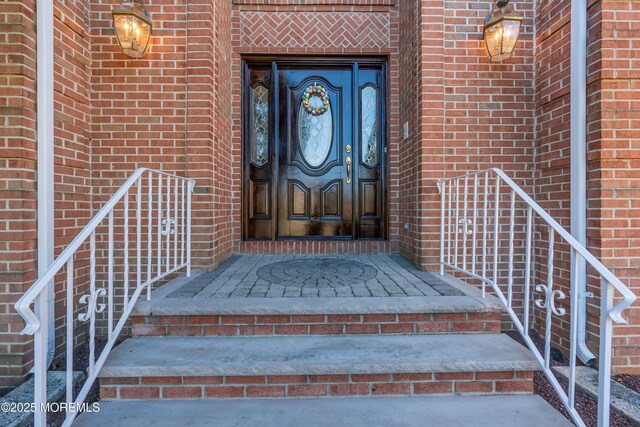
[483,0,522,62]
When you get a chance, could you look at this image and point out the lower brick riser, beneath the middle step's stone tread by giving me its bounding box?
[100,371,533,400]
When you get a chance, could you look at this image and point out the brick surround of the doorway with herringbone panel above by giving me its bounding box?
[231,0,402,253]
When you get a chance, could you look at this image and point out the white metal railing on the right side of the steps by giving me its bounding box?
[438,168,636,427]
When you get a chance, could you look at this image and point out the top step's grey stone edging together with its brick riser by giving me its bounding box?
[132,273,504,336]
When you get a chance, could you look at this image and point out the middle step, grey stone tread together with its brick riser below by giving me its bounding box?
[100,334,537,399]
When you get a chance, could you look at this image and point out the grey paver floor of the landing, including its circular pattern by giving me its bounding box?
[168,255,463,298]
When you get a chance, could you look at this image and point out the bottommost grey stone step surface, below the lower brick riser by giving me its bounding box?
[73,395,572,427]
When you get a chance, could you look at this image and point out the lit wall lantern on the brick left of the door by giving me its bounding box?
[112,0,152,58]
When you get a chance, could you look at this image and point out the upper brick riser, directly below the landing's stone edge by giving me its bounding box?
[132,313,501,336]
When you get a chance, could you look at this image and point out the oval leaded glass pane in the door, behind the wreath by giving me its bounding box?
[298,96,333,167]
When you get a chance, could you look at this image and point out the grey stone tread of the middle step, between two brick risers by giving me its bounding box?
[100,334,537,377]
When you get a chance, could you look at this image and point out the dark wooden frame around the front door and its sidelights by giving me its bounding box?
[240,54,390,241]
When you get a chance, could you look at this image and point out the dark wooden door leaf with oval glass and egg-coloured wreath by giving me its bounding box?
[278,69,354,239]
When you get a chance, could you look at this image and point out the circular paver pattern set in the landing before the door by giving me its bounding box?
[256,258,378,288]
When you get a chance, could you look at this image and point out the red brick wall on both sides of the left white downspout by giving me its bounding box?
[0,2,91,389]
